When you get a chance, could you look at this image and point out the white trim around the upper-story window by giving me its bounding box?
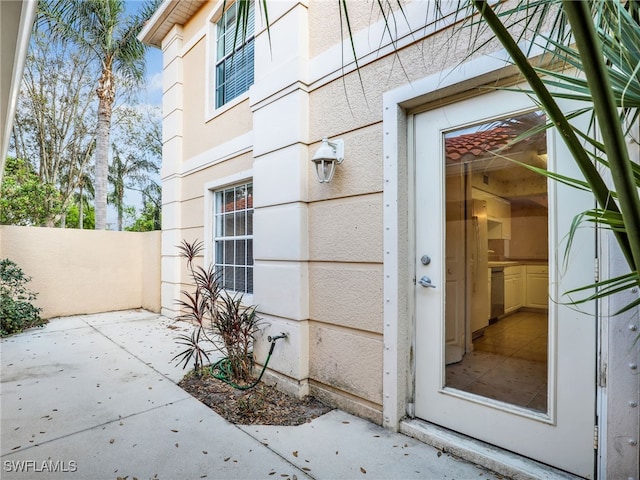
[204,0,255,122]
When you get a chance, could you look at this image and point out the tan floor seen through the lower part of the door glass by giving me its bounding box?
[446,311,548,412]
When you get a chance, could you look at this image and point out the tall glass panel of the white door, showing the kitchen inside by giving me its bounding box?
[443,112,549,412]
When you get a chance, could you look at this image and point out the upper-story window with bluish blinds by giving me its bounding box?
[215,0,255,108]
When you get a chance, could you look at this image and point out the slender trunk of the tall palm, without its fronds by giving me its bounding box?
[94,68,115,230]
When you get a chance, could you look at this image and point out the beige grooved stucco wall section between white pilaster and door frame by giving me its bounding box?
[308,2,498,422]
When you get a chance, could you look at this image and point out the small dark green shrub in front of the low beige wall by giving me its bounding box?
[0,258,47,337]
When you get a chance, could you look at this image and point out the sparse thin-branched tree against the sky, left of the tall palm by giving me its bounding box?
[12,29,96,226]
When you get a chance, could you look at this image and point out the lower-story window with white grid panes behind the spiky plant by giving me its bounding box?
[213,183,253,294]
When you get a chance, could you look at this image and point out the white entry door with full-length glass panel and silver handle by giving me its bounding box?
[413,88,596,478]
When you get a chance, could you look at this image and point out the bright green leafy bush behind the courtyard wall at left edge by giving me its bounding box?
[0,157,64,226]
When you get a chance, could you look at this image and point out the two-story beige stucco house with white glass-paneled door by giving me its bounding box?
[140,0,639,479]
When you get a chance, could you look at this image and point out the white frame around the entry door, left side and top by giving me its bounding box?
[383,47,606,474]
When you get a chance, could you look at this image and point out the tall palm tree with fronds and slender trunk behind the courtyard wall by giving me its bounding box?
[40,0,158,230]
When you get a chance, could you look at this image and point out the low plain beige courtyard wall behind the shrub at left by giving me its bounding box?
[0,226,160,318]
